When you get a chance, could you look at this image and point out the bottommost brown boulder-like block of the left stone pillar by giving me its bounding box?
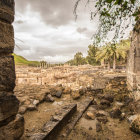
[0,115,24,140]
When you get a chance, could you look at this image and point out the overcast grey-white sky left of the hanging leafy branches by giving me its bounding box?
[14,0,97,62]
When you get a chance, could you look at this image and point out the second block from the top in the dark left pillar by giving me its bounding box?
[0,21,15,54]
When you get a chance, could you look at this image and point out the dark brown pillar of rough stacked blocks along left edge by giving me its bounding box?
[0,0,24,140]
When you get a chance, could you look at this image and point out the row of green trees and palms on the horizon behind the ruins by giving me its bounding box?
[67,40,130,69]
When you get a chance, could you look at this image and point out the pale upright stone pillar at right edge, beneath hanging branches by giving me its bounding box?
[127,19,140,99]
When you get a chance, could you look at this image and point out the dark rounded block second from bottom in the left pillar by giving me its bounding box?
[0,95,19,127]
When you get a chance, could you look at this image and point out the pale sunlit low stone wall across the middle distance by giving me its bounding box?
[16,66,95,86]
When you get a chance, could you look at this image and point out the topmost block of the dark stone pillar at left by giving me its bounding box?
[0,0,15,24]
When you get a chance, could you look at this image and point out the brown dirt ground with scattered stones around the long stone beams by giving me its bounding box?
[15,67,140,140]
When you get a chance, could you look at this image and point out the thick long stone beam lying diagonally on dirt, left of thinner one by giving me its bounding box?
[28,104,77,140]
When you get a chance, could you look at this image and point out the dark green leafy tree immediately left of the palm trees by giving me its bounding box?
[87,45,99,65]
